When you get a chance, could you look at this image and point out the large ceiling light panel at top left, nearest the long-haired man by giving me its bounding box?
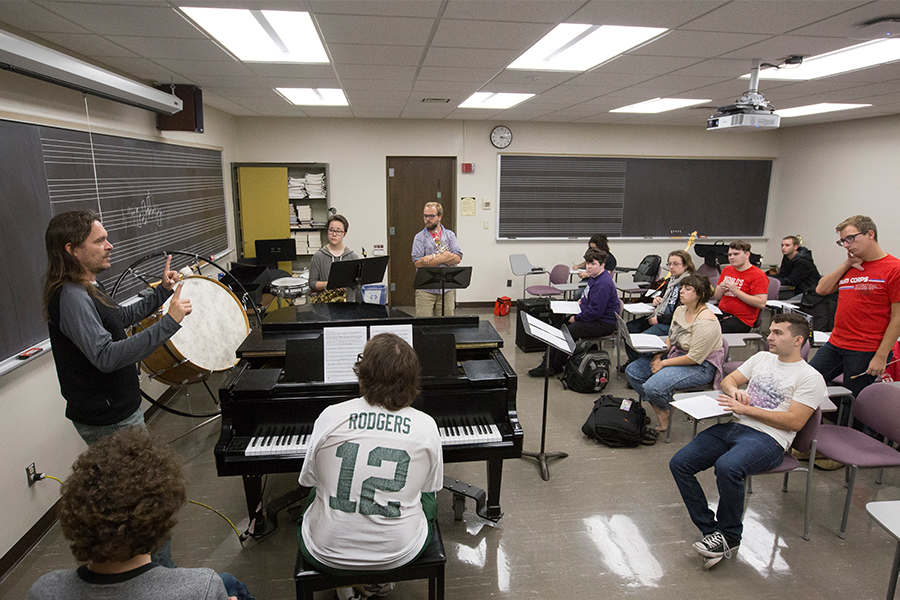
[181,6,328,63]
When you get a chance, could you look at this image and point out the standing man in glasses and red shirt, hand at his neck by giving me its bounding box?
[810,215,900,396]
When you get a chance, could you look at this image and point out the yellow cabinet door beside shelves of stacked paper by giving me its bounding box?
[237,167,292,273]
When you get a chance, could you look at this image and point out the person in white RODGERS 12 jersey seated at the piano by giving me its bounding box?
[300,333,444,599]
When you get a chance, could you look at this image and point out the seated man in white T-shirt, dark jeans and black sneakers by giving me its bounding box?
[669,313,826,569]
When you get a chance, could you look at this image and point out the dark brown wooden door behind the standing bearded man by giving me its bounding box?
[387,156,465,306]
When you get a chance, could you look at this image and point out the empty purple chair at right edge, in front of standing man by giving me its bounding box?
[817,383,900,539]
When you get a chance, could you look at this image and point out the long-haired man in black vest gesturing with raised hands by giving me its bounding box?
[44,210,191,444]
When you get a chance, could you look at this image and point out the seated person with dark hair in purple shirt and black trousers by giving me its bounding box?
[528,248,619,377]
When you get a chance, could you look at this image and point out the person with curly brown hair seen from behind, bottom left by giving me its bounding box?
[28,427,253,600]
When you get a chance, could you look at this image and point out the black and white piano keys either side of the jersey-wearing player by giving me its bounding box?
[244,422,503,457]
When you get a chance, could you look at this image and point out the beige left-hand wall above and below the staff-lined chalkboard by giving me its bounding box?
[0,71,235,555]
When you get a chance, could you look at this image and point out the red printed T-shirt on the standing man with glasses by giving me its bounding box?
[829,254,900,352]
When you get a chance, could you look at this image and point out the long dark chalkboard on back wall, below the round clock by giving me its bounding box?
[498,155,772,239]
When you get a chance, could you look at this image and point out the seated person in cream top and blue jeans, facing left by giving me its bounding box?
[625,274,725,445]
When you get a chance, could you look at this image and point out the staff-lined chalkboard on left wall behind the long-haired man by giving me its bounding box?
[0,120,228,359]
